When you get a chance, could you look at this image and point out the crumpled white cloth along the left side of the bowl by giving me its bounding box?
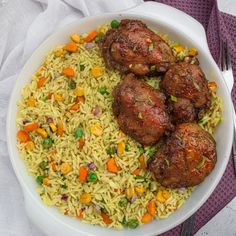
[0,0,142,236]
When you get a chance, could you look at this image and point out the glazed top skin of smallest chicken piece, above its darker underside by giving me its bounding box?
[161,62,211,109]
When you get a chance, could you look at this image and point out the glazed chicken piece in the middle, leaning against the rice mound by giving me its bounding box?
[113,74,171,145]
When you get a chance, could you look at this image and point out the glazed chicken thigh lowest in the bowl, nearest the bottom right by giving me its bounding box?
[148,123,216,188]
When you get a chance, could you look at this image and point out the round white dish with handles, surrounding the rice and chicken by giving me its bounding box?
[7,2,233,236]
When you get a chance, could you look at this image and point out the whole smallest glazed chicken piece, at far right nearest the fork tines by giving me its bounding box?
[161,62,211,123]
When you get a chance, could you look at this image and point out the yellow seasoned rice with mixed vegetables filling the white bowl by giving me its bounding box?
[17,22,222,229]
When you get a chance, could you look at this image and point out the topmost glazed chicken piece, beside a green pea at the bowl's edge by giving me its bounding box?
[99,19,175,75]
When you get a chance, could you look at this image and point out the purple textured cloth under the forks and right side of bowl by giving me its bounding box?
[146,0,236,236]
